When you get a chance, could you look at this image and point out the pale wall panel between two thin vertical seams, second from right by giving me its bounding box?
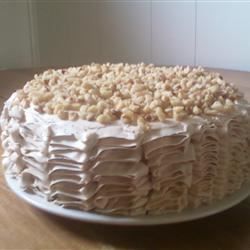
[151,1,196,65]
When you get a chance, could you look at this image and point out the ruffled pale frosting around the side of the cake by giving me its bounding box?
[1,94,250,215]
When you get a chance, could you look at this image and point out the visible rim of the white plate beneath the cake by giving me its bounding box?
[5,173,250,225]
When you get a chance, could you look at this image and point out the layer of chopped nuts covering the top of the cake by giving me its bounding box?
[16,63,242,127]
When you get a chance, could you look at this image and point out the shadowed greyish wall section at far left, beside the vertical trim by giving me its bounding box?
[0,1,32,68]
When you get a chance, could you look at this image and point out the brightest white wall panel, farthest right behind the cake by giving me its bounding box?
[196,1,250,71]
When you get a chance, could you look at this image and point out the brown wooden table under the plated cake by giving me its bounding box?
[0,69,250,250]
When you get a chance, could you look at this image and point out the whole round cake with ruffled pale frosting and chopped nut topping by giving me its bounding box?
[1,63,250,216]
